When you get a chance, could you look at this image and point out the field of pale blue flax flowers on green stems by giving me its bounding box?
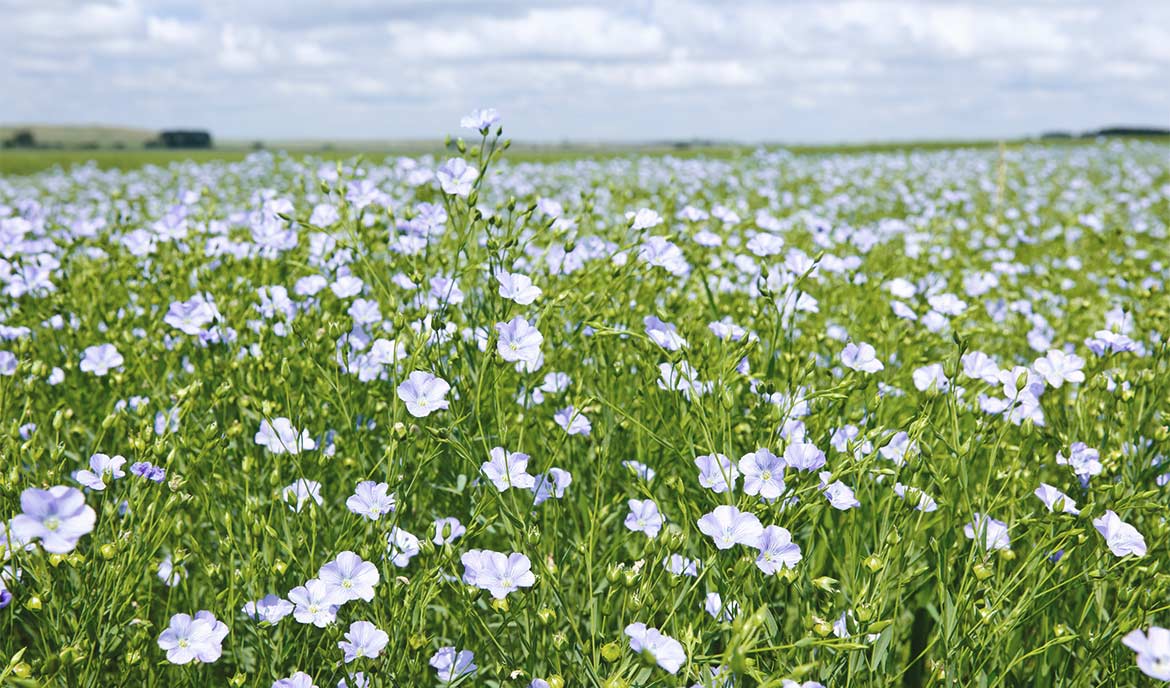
[0,109,1170,688]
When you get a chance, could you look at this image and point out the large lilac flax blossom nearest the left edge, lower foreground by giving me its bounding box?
[9,486,97,555]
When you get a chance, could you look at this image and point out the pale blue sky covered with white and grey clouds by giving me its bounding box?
[0,0,1170,142]
